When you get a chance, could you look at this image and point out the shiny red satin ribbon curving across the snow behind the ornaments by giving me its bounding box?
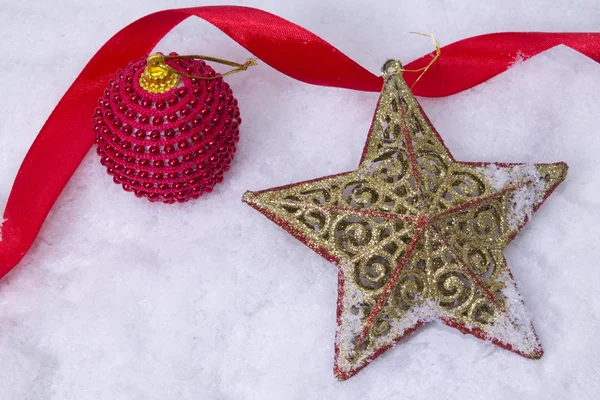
[0,6,600,278]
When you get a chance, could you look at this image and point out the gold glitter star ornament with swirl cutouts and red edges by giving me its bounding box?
[244,60,567,379]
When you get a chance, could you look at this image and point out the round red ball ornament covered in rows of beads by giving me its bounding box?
[94,53,242,203]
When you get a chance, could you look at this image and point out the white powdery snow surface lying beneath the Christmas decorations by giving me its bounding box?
[0,0,600,400]
